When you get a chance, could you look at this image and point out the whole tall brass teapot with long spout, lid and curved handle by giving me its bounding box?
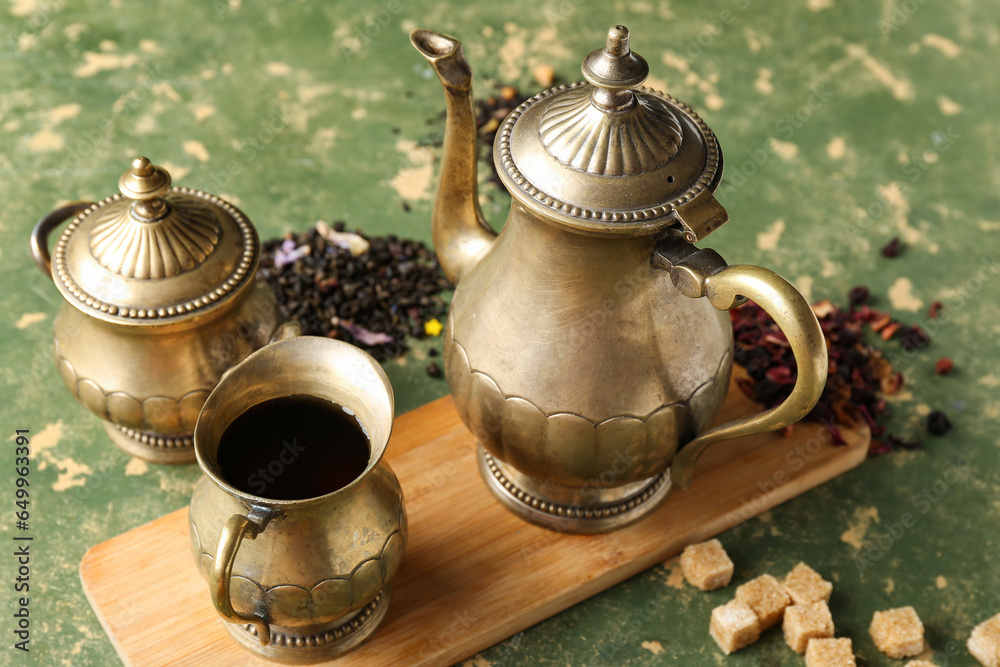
[410,26,827,533]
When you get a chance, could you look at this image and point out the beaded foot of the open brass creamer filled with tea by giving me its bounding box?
[224,584,392,665]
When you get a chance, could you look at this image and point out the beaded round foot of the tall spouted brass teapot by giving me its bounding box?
[477,446,670,534]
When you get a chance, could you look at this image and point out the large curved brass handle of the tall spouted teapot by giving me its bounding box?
[653,236,829,489]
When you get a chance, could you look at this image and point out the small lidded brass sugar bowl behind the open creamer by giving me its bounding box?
[31,157,281,463]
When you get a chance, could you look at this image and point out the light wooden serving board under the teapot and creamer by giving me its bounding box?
[80,386,869,667]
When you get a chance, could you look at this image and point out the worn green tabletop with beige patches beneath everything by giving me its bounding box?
[0,0,1000,667]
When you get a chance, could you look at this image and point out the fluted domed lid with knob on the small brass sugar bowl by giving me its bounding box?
[52,157,260,326]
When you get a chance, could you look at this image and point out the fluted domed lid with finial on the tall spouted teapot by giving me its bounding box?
[494,25,729,242]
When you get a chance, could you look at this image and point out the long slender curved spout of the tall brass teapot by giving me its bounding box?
[410,30,496,285]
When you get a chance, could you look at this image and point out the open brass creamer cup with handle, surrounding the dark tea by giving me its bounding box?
[189,336,407,663]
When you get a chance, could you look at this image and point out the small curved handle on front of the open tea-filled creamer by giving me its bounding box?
[208,507,271,646]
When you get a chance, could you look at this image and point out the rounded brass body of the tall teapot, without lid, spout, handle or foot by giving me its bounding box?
[445,201,732,497]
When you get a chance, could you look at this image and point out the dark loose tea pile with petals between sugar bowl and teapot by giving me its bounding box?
[257,221,451,359]
